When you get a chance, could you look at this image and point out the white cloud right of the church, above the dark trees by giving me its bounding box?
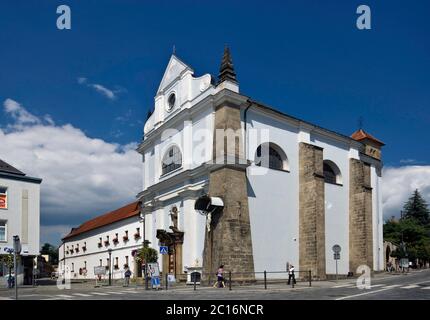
[382,166,430,219]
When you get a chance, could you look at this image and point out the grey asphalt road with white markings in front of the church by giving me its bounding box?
[0,269,430,300]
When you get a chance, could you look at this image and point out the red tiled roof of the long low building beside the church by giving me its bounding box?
[63,201,140,240]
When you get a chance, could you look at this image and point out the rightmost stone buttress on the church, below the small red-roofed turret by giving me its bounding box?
[349,159,373,274]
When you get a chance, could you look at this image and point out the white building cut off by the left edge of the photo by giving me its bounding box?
[0,160,42,286]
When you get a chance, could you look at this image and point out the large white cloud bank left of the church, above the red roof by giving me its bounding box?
[0,99,141,245]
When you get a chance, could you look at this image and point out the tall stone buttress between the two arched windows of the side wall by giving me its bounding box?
[299,142,326,279]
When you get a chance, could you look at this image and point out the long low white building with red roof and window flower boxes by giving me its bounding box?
[58,202,144,279]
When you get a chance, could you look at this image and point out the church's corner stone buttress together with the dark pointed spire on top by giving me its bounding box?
[203,47,254,281]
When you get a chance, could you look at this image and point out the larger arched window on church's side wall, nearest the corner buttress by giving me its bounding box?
[255,143,288,170]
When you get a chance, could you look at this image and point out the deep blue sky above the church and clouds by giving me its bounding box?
[0,0,430,245]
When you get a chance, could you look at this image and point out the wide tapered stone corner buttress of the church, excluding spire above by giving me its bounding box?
[203,100,255,282]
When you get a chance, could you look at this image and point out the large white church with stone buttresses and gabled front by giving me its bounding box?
[137,48,384,279]
